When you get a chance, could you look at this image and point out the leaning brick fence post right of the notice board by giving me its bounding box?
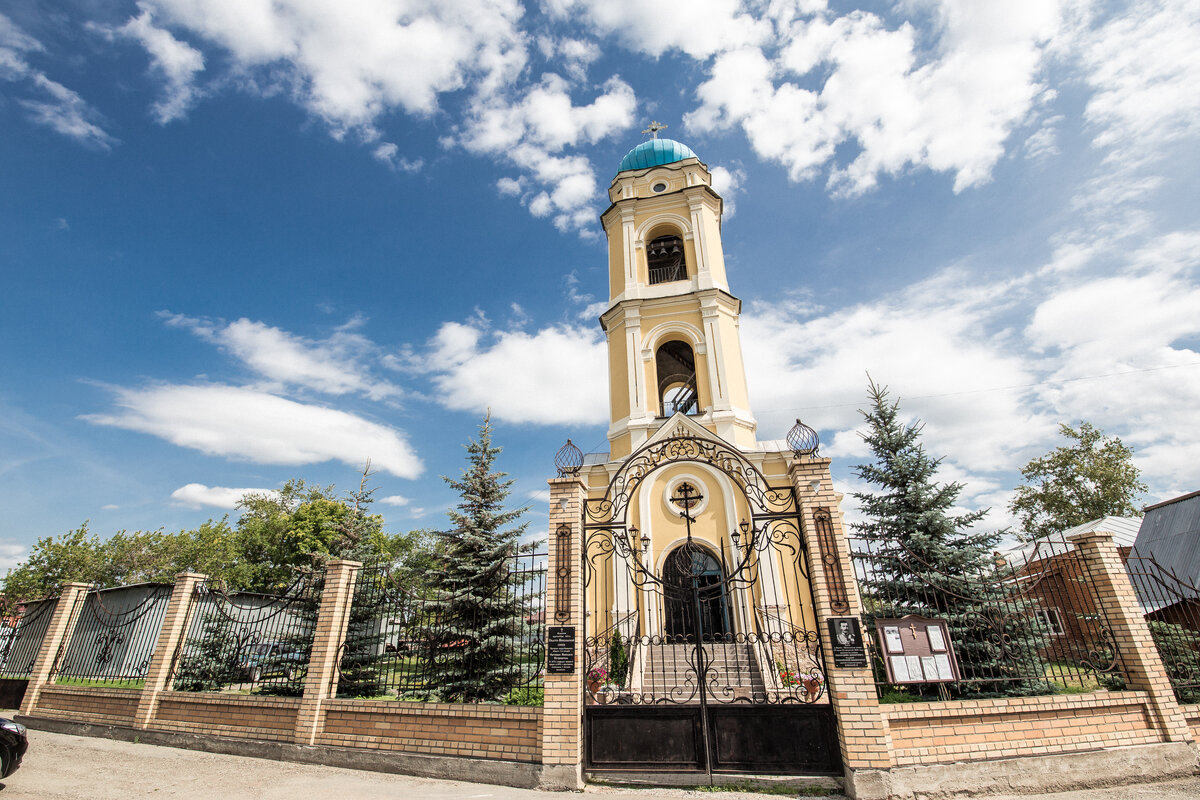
[1072,530,1193,742]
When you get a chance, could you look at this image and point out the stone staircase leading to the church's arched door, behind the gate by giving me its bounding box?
[641,642,767,703]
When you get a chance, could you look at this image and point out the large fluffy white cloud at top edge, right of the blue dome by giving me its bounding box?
[685,0,1061,194]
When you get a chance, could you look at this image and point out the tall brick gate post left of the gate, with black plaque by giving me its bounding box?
[540,476,587,790]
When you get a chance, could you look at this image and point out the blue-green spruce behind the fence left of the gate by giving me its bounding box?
[426,414,533,703]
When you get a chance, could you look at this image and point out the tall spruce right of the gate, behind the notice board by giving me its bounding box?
[853,381,1045,693]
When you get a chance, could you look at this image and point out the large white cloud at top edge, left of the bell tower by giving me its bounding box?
[140,0,526,139]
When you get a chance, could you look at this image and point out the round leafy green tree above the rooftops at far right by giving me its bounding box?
[1008,422,1146,541]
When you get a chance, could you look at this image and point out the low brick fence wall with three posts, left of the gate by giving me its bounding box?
[20,561,559,788]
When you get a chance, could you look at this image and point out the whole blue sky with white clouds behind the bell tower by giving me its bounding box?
[0,0,1200,566]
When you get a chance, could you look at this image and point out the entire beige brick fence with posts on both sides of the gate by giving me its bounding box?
[11,520,1200,800]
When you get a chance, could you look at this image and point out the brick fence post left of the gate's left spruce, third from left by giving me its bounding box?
[295,561,362,745]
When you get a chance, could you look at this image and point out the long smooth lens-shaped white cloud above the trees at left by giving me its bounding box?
[83,384,422,477]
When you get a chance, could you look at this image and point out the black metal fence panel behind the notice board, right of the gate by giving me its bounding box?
[852,537,1124,700]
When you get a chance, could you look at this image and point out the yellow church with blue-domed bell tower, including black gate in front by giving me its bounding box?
[551,136,848,772]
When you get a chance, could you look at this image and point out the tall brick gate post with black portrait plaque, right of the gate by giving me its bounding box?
[790,456,895,800]
